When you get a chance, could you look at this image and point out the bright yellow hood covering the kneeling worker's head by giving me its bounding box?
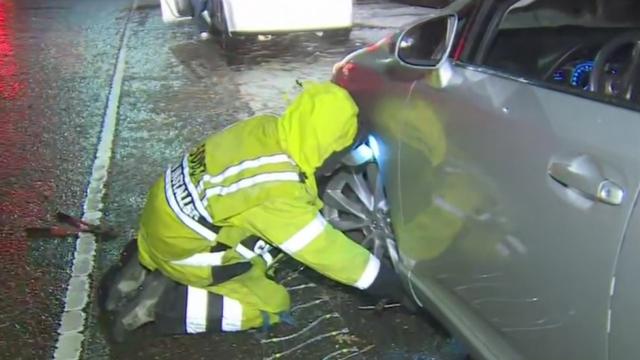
[278,82,358,174]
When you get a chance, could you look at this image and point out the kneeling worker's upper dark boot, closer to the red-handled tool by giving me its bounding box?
[104,239,149,311]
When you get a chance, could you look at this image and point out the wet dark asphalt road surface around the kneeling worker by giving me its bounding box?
[0,0,460,360]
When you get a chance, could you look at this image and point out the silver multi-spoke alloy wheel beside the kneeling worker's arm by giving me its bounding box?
[319,162,398,265]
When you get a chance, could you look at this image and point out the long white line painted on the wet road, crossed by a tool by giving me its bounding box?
[53,0,137,360]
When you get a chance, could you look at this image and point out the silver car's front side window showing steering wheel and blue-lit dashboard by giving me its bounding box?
[479,0,640,103]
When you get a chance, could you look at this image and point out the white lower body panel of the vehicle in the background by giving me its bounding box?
[210,0,353,34]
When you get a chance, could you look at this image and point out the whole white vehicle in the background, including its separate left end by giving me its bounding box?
[160,0,353,45]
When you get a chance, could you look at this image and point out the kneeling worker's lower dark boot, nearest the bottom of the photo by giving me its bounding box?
[111,271,172,342]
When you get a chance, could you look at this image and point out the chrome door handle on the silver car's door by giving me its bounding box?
[547,155,624,205]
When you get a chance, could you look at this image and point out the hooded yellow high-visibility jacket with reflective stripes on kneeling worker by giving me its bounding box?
[138,83,380,313]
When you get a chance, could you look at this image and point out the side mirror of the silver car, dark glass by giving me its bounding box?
[396,15,458,69]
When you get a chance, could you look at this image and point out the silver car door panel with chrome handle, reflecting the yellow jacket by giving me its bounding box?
[395,2,640,359]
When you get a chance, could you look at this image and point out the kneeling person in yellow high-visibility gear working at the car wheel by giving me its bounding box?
[105,83,402,338]
